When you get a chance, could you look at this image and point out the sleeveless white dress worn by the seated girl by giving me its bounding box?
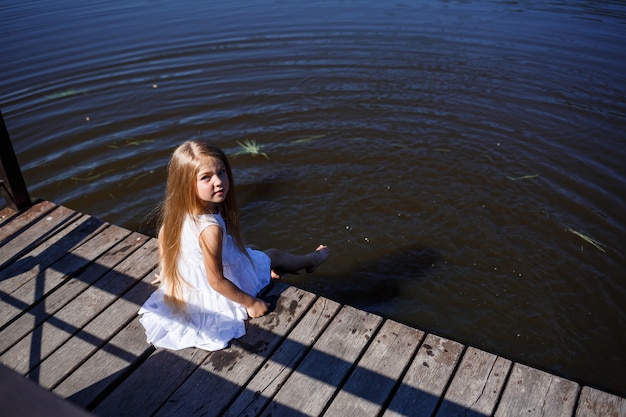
[138,214,270,350]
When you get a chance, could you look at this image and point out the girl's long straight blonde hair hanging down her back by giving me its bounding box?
[158,140,247,313]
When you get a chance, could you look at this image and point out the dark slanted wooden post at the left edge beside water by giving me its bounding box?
[0,111,31,211]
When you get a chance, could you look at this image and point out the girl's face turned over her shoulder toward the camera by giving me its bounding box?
[196,157,230,213]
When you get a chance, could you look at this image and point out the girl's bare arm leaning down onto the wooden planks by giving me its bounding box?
[200,225,268,317]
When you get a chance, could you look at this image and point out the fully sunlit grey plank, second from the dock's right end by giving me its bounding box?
[495,363,579,417]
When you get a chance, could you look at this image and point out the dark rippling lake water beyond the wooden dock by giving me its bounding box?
[0,0,626,395]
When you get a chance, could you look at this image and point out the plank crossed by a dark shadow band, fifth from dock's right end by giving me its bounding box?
[324,320,424,417]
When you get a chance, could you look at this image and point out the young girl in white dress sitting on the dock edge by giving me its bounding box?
[139,140,329,350]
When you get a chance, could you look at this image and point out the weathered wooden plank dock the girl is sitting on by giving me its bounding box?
[0,201,626,417]
